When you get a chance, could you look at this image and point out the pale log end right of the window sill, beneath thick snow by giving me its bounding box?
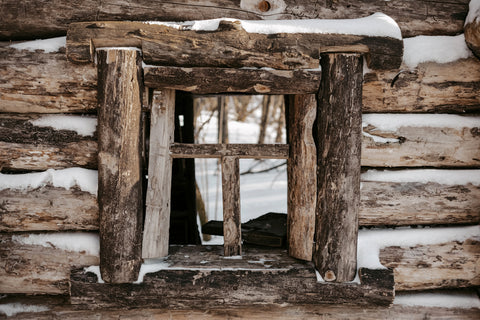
[380,237,480,291]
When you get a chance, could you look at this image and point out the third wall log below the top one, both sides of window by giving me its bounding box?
[0,171,480,232]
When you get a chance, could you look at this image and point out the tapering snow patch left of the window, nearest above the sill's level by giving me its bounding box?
[12,232,100,256]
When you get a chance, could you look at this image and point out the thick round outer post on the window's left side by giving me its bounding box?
[97,49,143,283]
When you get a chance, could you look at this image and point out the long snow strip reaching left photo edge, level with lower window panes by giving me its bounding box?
[0,168,98,196]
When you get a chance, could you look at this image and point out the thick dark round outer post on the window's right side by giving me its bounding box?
[314,53,363,282]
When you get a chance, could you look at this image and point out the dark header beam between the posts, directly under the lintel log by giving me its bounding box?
[144,66,321,94]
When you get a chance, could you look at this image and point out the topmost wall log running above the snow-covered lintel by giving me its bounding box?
[0,0,469,40]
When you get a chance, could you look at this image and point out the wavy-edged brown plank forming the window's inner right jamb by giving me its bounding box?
[287,94,317,261]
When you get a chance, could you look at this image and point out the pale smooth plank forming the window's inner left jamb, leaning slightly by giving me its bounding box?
[142,89,175,258]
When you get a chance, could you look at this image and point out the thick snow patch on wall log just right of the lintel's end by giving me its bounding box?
[403,34,472,69]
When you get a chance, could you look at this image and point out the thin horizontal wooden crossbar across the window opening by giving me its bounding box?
[170,143,288,159]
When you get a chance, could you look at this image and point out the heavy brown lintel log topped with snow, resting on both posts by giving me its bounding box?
[67,21,403,70]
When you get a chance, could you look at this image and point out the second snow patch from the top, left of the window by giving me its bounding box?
[29,114,97,136]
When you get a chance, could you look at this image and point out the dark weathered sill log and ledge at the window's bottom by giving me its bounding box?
[70,246,394,309]
